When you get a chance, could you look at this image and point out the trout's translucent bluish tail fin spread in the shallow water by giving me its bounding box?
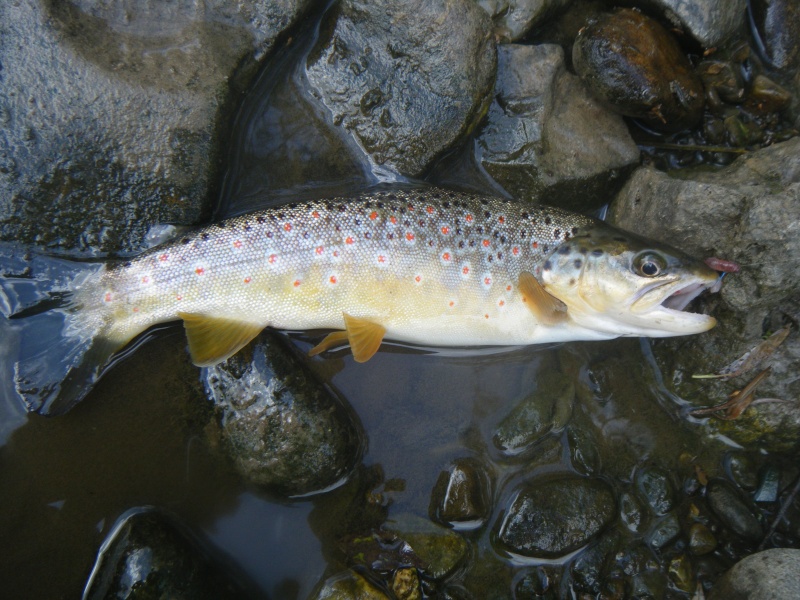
[0,247,120,415]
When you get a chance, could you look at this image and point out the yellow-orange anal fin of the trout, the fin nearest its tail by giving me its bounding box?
[178,313,264,367]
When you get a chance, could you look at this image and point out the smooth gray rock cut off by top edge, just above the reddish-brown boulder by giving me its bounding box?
[640,0,747,48]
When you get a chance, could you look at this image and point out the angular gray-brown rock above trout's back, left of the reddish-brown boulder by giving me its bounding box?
[477,44,639,210]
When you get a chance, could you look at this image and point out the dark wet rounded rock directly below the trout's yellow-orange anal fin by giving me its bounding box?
[201,332,364,496]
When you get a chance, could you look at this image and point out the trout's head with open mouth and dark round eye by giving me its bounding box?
[540,226,719,337]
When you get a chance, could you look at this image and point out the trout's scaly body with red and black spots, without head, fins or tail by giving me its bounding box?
[90,190,594,345]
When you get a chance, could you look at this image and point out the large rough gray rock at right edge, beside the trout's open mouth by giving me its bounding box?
[609,138,800,450]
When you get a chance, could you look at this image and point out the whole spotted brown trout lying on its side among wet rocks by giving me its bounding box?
[3,189,718,412]
